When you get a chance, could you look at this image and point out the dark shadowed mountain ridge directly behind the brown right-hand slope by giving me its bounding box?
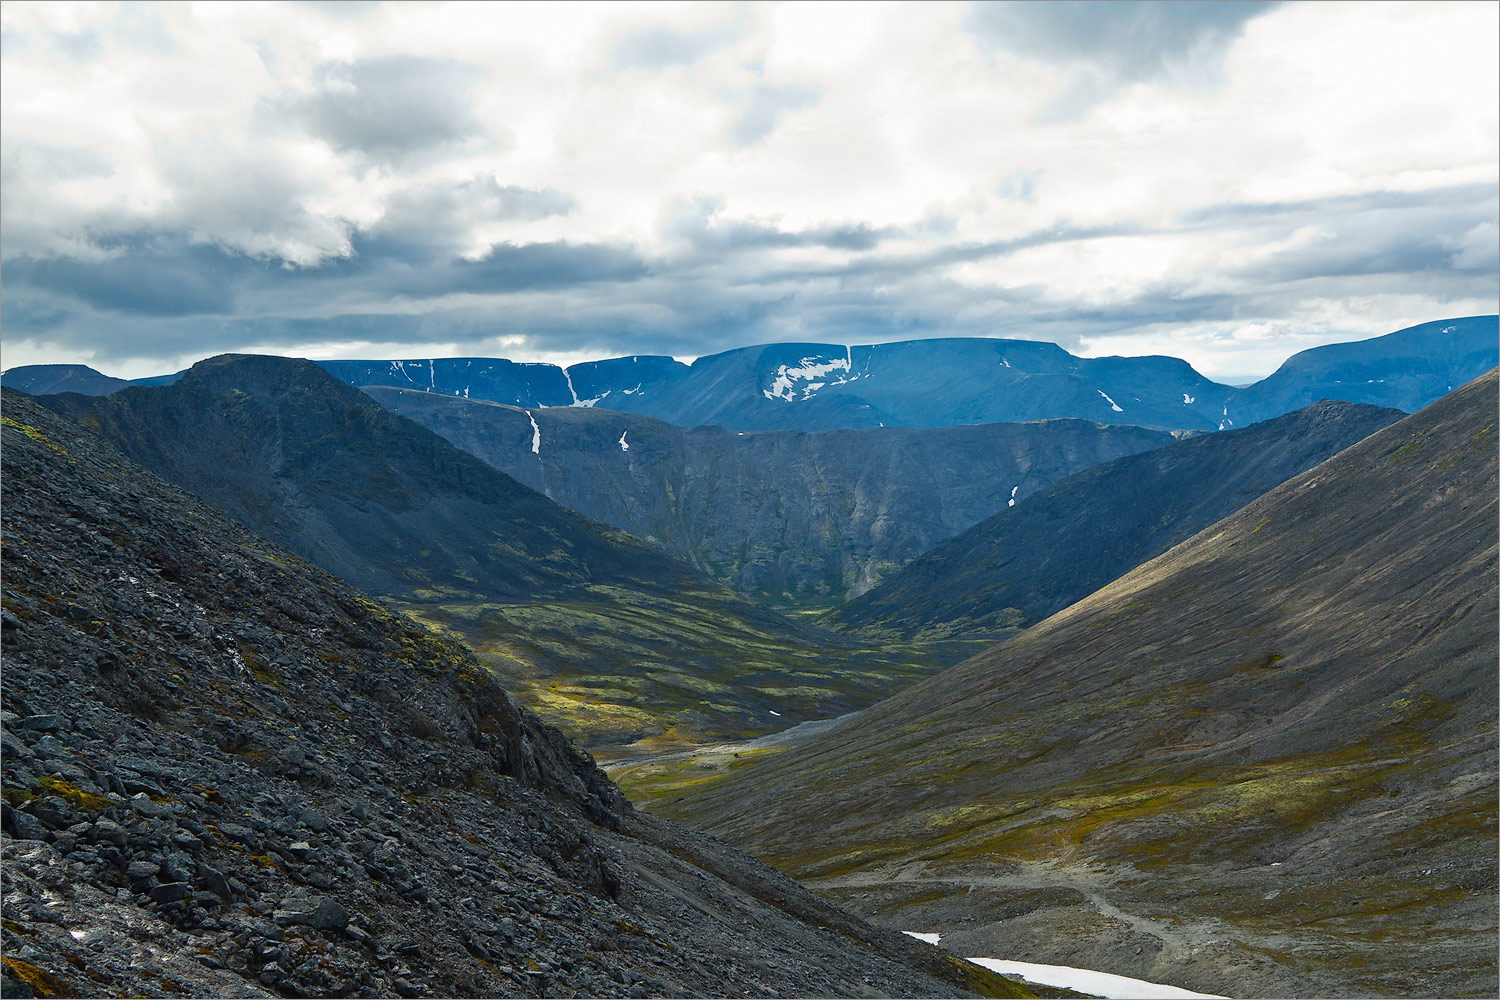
[824,400,1404,639]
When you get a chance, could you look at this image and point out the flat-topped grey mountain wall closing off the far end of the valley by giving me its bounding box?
[365,387,1173,607]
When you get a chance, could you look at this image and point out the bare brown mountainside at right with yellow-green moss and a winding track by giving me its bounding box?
[627,372,1500,997]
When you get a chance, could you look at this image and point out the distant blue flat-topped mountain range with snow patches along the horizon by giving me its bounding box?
[3,316,1500,430]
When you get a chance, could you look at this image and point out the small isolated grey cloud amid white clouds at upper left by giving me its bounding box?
[267,54,497,165]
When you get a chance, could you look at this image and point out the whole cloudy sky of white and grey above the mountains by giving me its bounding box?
[0,0,1500,378]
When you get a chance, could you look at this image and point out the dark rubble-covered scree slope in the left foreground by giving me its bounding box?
[0,393,1029,997]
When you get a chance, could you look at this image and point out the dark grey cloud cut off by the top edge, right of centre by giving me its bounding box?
[965,0,1280,120]
